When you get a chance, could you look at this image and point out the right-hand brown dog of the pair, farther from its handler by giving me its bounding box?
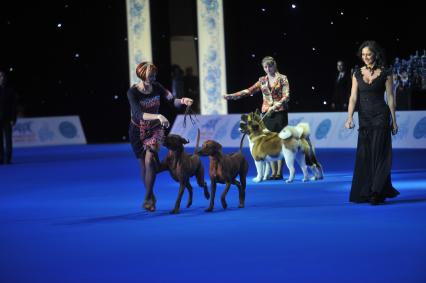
[198,135,248,211]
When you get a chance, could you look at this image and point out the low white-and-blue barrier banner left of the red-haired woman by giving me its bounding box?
[13,116,86,147]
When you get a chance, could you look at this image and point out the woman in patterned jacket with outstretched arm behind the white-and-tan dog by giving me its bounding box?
[223,56,290,180]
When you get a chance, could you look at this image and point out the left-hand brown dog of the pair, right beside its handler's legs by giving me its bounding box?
[159,130,210,214]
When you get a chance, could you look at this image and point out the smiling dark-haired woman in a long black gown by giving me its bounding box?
[345,41,399,205]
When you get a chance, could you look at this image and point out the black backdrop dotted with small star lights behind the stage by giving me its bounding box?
[0,0,426,143]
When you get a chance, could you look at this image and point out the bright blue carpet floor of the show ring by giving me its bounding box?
[0,144,426,283]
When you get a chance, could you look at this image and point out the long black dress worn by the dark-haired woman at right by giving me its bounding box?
[349,69,399,202]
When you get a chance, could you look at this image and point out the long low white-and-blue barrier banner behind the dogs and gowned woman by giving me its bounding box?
[171,111,426,148]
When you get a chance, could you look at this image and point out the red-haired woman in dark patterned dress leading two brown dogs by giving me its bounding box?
[127,62,193,211]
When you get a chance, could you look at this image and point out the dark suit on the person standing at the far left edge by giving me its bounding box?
[0,86,16,164]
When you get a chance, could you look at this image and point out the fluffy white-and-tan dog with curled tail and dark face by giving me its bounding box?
[240,110,323,183]
